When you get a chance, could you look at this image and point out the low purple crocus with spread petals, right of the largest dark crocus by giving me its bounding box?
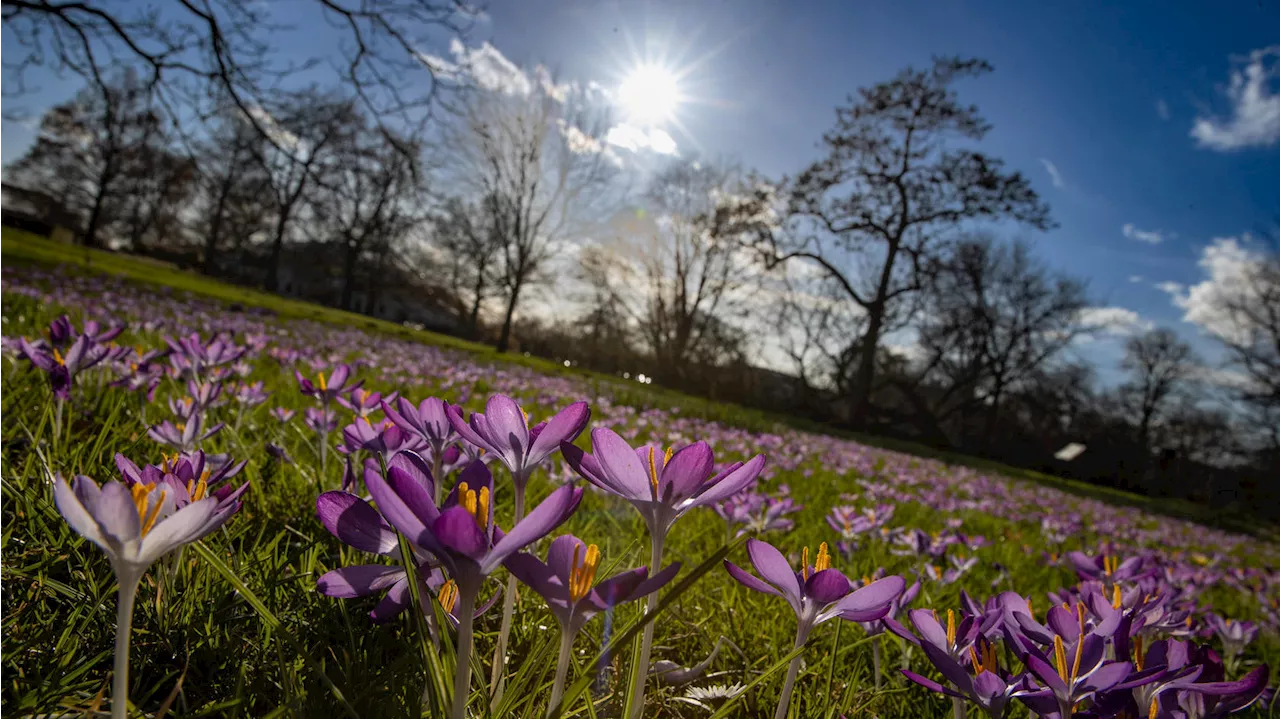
[507,535,680,715]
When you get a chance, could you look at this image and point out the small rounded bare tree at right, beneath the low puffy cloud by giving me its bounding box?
[1120,329,1198,453]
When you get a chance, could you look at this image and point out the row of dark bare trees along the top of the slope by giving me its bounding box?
[5,12,1280,514]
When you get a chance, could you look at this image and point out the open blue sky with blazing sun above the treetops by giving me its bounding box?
[0,0,1280,381]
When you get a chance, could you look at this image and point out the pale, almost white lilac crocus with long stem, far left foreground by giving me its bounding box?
[54,476,238,719]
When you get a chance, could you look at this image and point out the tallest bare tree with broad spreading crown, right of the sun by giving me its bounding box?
[765,58,1052,422]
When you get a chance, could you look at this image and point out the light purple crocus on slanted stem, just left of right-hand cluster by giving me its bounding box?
[724,539,906,719]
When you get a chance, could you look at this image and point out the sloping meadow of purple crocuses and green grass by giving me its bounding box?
[0,235,1280,718]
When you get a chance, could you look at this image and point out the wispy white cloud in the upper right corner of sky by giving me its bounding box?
[1190,45,1280,152]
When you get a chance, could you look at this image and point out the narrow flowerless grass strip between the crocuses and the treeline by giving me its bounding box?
[0,228,1280,540]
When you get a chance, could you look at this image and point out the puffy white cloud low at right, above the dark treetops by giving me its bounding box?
[1160,234,1265,339]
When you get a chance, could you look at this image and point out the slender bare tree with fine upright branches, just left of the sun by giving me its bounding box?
[449,82,617,352]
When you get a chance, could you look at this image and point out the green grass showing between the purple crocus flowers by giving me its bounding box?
[0,234,1280,719]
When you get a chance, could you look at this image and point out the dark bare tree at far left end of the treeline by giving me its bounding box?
[9,73,163,247]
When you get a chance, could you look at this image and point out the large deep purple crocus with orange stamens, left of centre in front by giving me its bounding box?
[365,463,582,719]
